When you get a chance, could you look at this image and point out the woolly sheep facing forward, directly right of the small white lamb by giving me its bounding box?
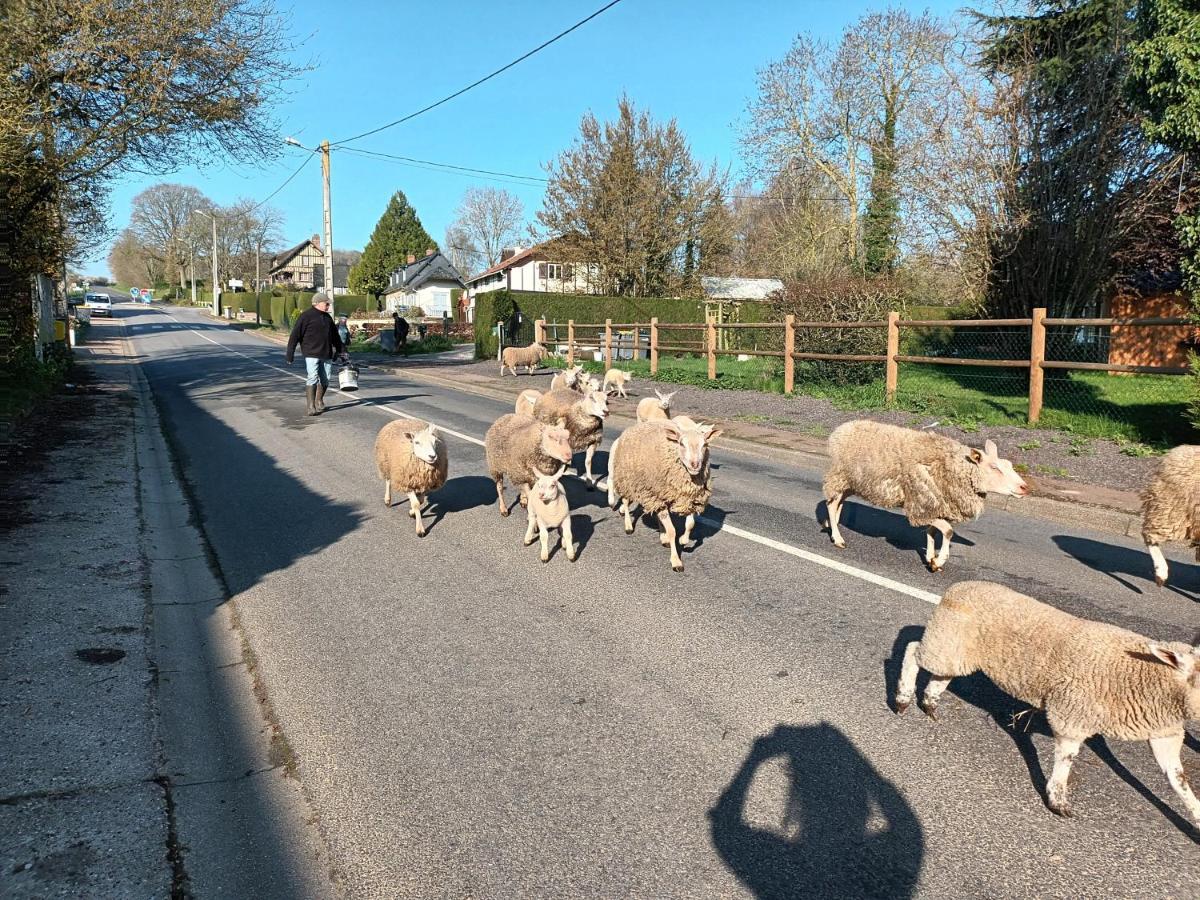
[608,420,721,572]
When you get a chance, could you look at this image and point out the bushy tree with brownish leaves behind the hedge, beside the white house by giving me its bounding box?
[538,97,732,296]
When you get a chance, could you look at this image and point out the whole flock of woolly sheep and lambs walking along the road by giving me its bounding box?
[376,344,1200,828]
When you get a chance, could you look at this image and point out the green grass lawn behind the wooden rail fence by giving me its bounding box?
[550,354,1195,455]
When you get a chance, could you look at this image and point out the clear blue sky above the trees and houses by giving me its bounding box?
[78,0,960,274]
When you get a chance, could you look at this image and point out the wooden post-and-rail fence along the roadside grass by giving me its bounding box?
[523,308,1193,422]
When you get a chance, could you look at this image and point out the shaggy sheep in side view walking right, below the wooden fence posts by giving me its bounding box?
[824,419,1028,572]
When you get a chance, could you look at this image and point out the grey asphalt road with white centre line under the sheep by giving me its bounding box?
[116,304,1200,898]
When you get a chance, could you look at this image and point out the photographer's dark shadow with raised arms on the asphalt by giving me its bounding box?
[709,722,924,900]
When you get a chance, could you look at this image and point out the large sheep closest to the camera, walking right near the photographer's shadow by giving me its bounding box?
[895,581,1200,827]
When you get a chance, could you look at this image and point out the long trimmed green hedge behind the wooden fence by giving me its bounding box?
[475,289,775,359]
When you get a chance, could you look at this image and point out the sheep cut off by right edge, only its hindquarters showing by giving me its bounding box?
[1141,444,1200,587]
